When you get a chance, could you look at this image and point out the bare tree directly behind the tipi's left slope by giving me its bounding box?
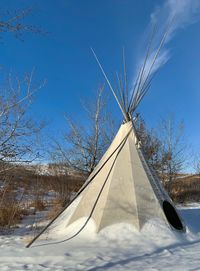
[53,86,114,173]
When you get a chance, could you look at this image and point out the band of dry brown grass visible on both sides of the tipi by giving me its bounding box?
[0,164,200,232]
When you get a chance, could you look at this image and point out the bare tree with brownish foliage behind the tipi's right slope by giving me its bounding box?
[136,115,188,187]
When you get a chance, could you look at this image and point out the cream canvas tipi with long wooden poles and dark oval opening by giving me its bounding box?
[27,31,185,247]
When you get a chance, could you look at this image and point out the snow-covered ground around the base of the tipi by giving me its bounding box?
[0,204,200,271]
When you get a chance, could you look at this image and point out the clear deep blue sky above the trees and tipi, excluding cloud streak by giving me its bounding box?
[0,0,200,160]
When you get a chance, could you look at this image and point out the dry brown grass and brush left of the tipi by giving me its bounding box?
[0,166,86,229]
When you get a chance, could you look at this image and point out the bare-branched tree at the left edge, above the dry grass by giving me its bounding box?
[0,69,44,170]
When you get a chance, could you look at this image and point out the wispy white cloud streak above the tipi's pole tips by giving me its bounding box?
[135,0,200,86]
